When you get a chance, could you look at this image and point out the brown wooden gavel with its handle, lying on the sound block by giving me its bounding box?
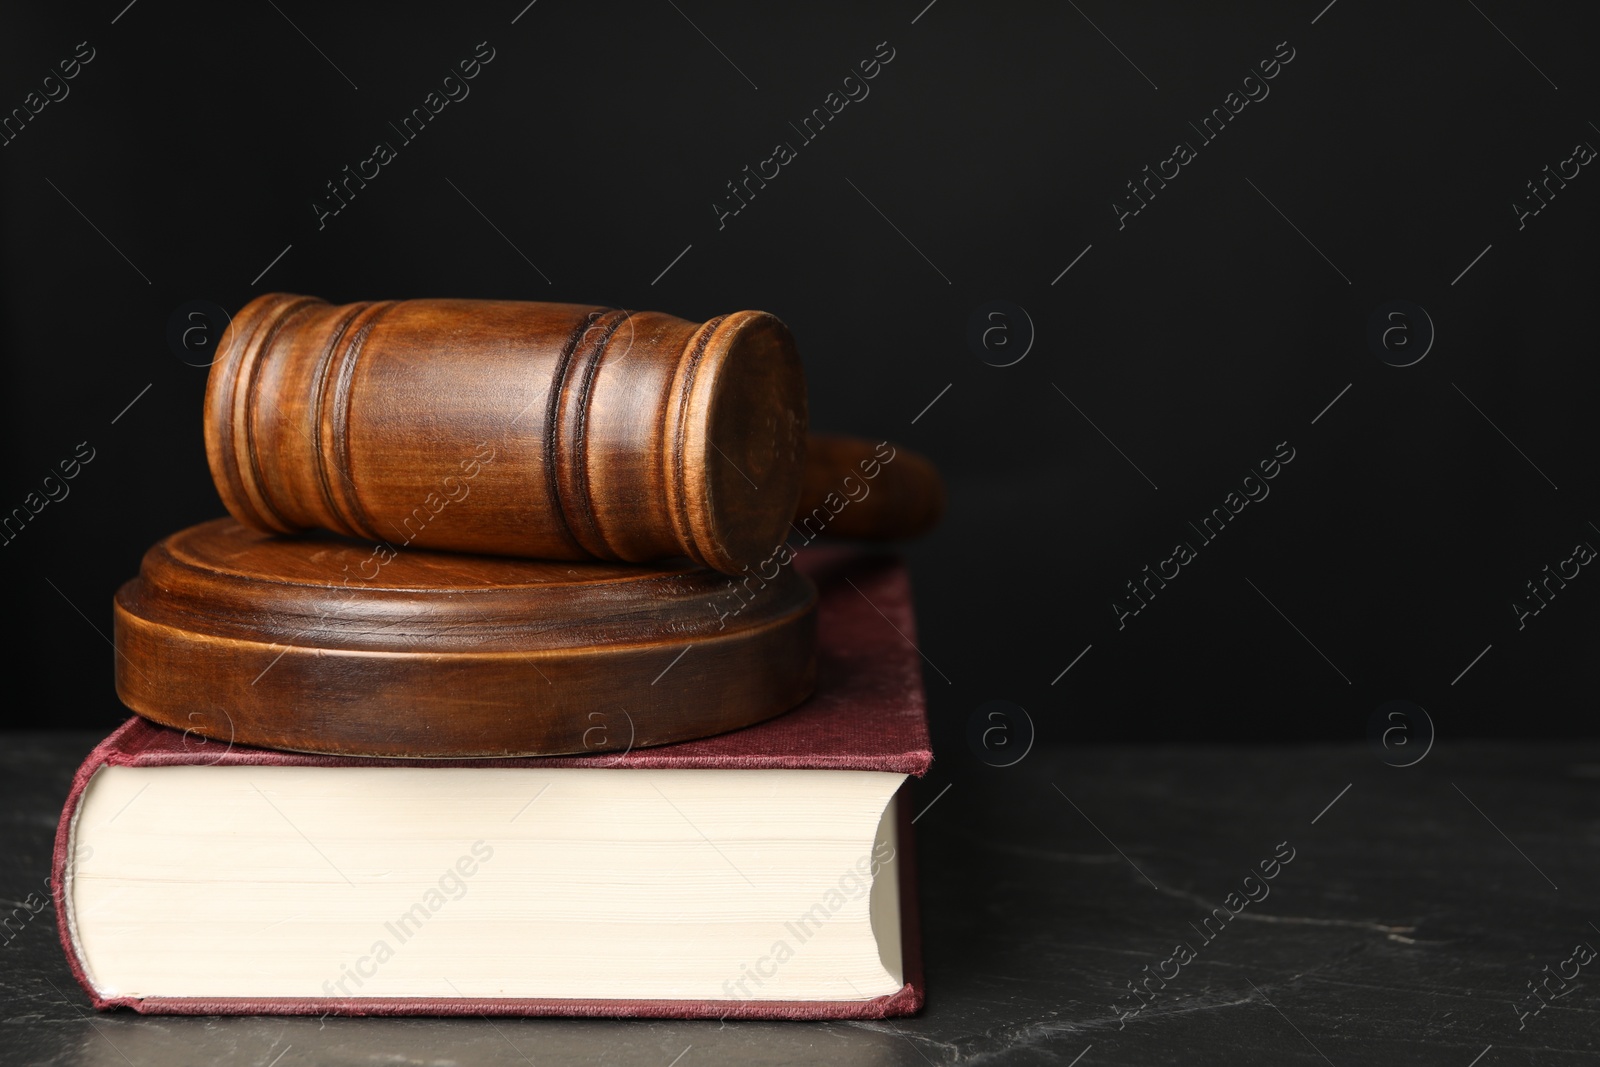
[205,293,944,574]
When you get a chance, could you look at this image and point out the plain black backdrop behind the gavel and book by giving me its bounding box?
[0,0,1600,742]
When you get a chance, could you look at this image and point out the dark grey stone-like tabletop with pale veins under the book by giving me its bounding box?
[0,733,1600,1067]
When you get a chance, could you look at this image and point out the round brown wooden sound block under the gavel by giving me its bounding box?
[115,518,818,758]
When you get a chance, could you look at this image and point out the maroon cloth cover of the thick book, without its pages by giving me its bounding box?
[51,549,933,1019]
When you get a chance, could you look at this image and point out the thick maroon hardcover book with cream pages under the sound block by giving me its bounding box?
[51,549,933,1019]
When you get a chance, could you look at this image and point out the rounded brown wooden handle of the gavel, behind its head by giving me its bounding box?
[795,434,944,541]
